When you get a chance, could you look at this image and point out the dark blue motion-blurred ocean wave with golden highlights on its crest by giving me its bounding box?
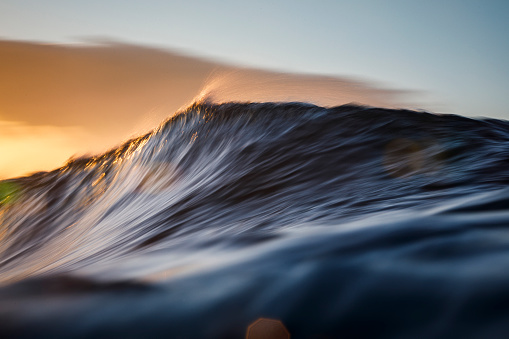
[0,102,509,338]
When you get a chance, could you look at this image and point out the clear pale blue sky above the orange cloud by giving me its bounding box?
[0,0,509,119]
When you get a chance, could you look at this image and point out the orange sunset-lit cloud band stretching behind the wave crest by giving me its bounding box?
[0,40,414,177]
